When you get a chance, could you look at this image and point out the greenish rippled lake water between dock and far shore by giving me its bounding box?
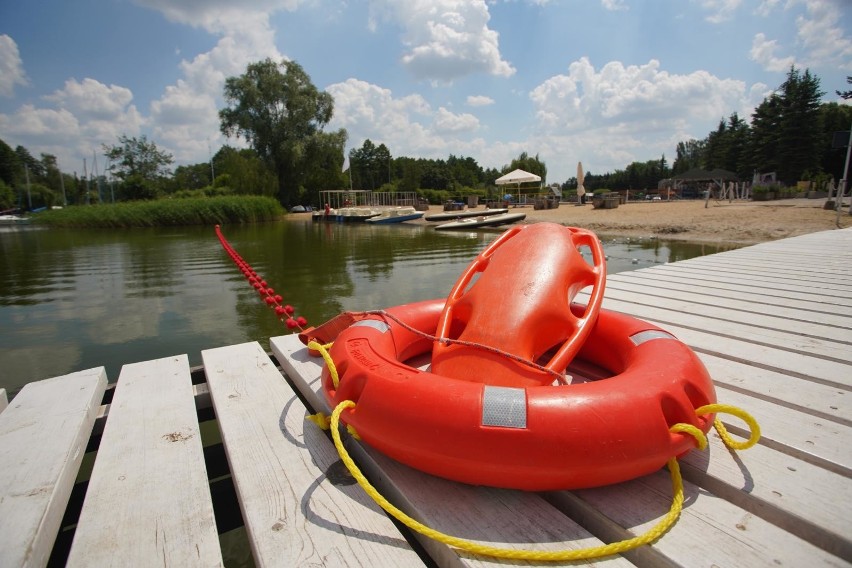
[0,219,730,396]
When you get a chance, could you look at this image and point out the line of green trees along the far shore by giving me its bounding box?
[0,65,852,209]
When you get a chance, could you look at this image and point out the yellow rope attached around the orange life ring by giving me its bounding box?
[308,400,760,562]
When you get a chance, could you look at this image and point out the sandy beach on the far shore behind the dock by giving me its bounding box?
[422,199,852,244]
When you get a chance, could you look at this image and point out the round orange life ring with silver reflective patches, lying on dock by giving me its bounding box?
[322,300,716,491]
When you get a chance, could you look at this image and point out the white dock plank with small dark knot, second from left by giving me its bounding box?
[67,355,223,566]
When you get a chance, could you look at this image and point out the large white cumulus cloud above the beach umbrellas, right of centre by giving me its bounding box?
[529,58,764,181]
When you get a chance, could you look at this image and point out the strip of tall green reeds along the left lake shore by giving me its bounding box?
[33,196,284,228]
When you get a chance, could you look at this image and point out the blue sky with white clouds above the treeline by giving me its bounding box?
[0,0,852,182]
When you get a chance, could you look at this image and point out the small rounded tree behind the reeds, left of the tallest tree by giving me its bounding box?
[103,135,174,199]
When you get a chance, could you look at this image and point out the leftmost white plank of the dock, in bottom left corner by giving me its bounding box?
[0,367,107,566]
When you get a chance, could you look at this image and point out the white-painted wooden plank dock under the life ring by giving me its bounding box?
[0,229,852,567]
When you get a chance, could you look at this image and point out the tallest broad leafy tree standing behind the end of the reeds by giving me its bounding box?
[219,59,345,206]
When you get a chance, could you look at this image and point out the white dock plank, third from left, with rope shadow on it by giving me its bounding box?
[202,343,422,567]
